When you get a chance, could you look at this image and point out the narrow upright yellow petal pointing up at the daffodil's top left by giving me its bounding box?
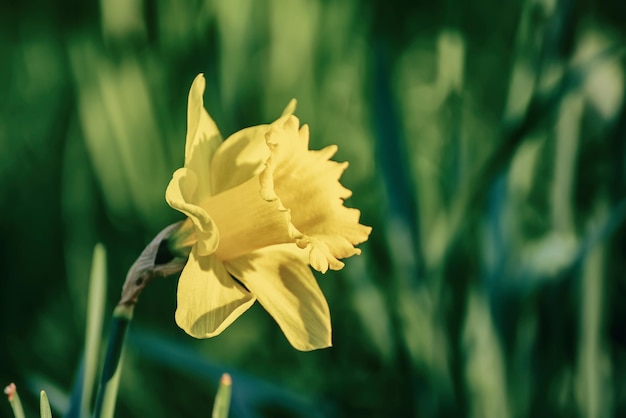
[185,74,222,199]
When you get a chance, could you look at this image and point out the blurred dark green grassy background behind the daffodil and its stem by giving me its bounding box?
[0,0,626,418]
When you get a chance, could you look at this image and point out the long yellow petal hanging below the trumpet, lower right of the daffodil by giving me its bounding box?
[225,244,332,351]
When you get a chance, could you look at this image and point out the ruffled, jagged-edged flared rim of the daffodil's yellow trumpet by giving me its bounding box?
[261,116,371,273]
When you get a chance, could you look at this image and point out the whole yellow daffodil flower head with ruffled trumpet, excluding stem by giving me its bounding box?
[166,74,371,350]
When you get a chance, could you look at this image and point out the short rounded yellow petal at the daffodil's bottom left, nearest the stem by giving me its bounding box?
[176,248,254,338]
